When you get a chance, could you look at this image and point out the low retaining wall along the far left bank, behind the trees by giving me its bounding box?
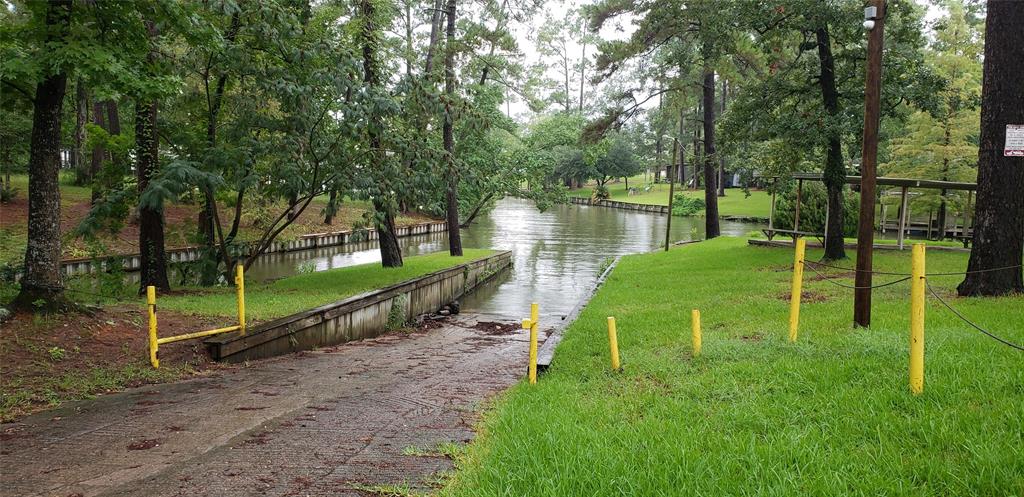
[60,221,447,276]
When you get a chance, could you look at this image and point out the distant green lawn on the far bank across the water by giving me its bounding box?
[569,176,771,218]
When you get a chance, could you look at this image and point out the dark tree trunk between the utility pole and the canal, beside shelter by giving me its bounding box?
[815,27,846,260]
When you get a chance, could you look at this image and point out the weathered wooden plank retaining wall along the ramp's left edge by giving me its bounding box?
[205,251,512,362]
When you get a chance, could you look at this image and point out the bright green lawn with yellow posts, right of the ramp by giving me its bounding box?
[442,239,1024,496]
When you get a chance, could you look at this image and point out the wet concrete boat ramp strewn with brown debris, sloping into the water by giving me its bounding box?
[0,315,543,497]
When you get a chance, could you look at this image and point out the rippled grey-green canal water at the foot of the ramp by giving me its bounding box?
[247,198,763,322]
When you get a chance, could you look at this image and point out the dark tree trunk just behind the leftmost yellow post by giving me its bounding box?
[135,20,171,295]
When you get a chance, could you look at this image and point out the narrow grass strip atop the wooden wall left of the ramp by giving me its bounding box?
[157,249,494,322]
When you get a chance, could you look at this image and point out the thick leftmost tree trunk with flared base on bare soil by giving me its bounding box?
[11,0,72,312]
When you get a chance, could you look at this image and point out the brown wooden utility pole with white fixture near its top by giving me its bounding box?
[853,0,886,328]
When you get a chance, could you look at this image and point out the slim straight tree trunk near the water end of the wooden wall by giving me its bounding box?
[441,0,462,257]
